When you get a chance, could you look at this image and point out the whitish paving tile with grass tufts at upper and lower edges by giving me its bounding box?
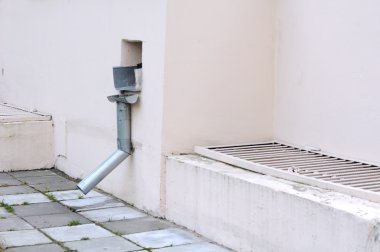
[41,224,114,242]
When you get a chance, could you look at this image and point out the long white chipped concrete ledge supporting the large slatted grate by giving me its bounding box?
[166,155,380,252]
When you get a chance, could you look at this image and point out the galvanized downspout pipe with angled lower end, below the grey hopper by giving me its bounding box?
[77,65,139,194]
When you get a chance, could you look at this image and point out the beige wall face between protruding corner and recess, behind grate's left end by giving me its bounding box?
[163,0,274,153]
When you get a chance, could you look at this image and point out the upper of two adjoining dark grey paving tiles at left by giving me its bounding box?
[13,202,71,217]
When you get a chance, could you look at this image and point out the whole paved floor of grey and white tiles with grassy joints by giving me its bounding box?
[0,170,229,252]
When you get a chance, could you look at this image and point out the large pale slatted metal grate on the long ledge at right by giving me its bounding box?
[195,142,380,202]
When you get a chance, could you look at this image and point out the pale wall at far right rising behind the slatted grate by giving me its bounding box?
[274,0,380,163]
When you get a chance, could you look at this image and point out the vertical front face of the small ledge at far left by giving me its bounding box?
[0,120,54,171]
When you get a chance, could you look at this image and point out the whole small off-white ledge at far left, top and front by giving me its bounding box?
[0,103,54,171]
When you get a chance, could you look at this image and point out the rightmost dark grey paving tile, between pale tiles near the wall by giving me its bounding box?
[102,217,174,235]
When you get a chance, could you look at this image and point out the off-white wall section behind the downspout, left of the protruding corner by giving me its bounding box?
[0,0,166,213]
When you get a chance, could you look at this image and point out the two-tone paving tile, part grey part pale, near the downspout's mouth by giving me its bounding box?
[61,196,124,212]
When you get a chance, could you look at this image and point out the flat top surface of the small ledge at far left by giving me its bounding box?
[0,103,51,123]
